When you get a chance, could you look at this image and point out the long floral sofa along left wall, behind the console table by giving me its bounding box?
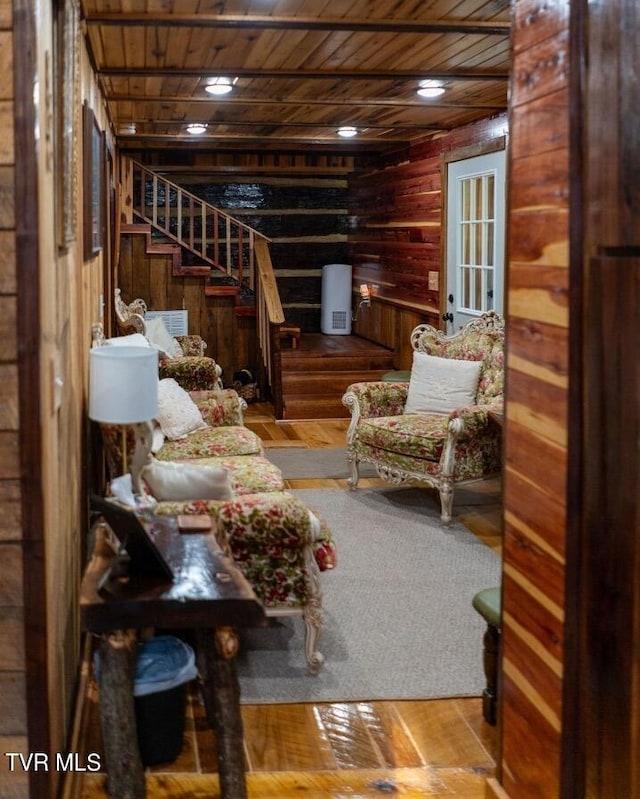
[101,378,336,671]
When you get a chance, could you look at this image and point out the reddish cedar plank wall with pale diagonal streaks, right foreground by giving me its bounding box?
[500,0,570,799]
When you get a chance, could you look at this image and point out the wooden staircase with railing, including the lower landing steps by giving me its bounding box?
[116,159,394,420]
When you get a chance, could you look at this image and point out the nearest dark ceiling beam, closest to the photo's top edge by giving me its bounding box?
[85,12,511,36]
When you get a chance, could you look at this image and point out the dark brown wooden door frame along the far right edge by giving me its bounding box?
[561,0,640,799]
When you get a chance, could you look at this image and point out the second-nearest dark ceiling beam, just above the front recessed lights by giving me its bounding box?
[98,67,509,82]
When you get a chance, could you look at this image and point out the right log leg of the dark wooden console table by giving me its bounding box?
[196,627,247,799]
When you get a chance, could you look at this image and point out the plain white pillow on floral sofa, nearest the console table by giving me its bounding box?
[142,460,233,501]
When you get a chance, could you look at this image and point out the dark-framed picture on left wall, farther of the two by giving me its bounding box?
[82,102,105,261]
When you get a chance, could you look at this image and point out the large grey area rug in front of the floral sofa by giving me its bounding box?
[238,488,500,704]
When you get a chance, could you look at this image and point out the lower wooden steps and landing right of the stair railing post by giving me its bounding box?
[280,333,394,421]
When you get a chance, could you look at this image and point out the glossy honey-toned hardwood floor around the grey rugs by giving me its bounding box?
[75,404,501,799]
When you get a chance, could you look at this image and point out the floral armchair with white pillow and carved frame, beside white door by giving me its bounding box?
[342,311,504,523]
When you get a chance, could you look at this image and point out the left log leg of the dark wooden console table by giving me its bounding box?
[100,631,145,799]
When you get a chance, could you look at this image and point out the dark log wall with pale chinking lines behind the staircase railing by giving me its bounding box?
[120,150,364,334]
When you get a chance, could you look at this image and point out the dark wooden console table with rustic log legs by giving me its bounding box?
[80,517,266,799]
